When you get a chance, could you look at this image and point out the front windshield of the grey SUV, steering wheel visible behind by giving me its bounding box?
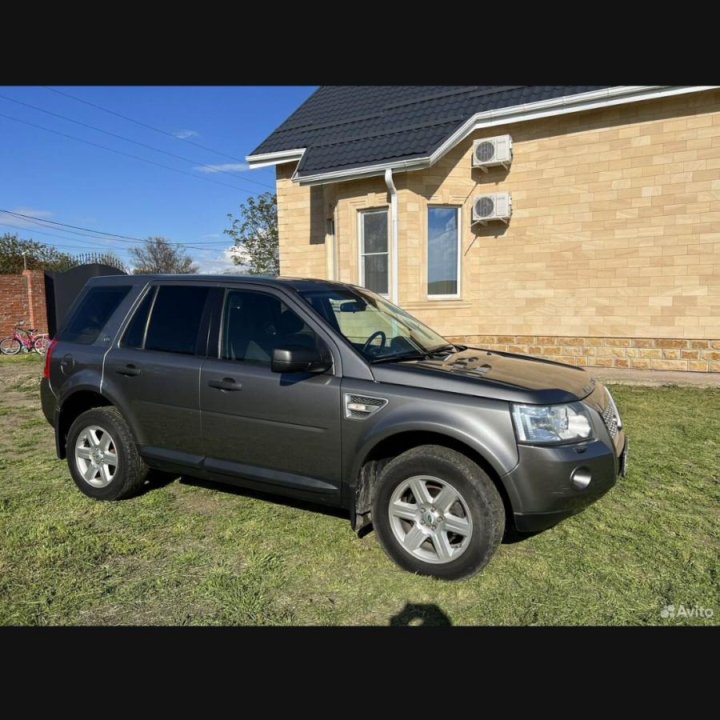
[300,288,455,362]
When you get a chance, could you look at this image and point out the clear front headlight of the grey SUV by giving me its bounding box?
[513,403,592,444]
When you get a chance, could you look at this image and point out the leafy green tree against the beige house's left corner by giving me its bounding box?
[223,192,280,275]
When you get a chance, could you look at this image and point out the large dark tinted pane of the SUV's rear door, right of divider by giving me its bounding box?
[145,285,208,355]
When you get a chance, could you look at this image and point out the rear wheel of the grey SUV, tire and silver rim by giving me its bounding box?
[67,407,148,500]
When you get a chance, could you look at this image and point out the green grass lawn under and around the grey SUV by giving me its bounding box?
[0,355,720,625]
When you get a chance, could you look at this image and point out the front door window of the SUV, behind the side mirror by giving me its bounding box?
[221,290,319,366]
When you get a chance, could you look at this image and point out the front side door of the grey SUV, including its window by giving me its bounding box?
[200,286,341,502]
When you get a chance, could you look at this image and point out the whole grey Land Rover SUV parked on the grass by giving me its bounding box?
[41,275,627,580]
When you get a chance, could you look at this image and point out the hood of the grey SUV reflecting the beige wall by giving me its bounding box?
[372,347,596,404]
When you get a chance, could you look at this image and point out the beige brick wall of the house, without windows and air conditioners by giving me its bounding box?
[278,90,720,370]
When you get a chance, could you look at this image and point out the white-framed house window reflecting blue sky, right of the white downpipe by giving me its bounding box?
[428,207,460,297]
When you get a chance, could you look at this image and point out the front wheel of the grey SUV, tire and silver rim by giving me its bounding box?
[372,445,505,580]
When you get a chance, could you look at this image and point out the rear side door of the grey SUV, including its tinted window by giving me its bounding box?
[104,283,210,469]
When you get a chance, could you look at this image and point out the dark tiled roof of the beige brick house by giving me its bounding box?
[251,85,612,177]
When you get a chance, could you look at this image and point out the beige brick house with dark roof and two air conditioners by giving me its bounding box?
[247,86,720,372]
